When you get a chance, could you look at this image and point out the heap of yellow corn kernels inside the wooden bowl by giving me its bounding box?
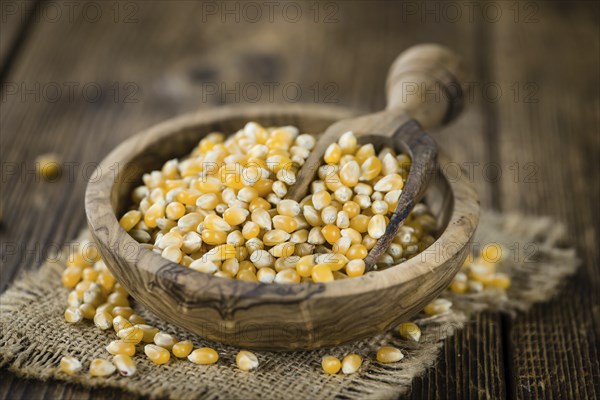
[120,122,436,283]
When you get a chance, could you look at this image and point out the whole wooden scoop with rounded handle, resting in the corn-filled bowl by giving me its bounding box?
[286,44,463,271]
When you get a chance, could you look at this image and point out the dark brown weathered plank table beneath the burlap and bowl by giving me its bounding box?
[0,0,600,399]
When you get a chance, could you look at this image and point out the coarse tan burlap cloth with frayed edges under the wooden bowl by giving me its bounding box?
[0,212,578,399]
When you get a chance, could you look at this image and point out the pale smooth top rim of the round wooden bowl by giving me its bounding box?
[85,104,479,301]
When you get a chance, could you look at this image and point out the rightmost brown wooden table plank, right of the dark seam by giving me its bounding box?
[494,2,600,399]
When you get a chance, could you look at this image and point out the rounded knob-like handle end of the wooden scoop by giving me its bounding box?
[386,44,464,130]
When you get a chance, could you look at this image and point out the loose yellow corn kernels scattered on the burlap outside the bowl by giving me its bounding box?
[60,242,510,377]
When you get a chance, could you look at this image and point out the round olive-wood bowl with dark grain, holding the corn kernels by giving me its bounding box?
[85,105,479,350]
